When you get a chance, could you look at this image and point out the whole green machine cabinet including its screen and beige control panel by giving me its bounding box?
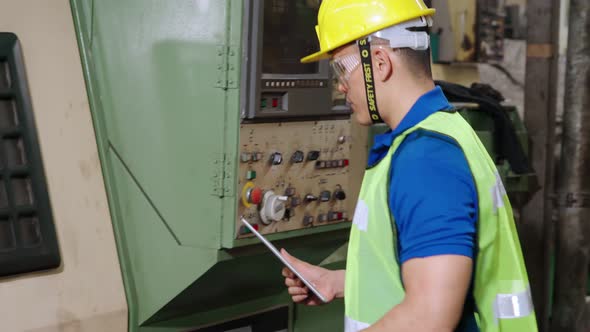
[72,0,366,331]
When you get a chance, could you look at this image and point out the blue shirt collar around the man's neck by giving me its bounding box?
[371,85,453,157]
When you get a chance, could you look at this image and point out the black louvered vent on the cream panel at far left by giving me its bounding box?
[0,32,60,276]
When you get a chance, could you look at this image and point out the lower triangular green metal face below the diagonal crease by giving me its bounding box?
[111,155,217,324]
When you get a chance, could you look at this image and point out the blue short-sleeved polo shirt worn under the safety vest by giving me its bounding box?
[368,86,479,332]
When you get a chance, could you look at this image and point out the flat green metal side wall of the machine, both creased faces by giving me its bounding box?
[72,0,241,331]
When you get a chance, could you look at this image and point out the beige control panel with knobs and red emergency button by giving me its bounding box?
[236,120,356,238]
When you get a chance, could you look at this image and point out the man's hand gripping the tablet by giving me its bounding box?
[281,249,344,305]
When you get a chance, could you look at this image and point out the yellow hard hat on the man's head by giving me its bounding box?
[301,0,435,63]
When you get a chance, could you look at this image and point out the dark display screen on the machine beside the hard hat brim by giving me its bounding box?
[262,0,321,74]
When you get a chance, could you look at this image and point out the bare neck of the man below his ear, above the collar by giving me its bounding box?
[380,77,434,129]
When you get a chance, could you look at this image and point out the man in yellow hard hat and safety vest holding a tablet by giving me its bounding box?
[283,0,537,332]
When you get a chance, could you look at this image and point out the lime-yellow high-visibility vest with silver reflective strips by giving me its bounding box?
[344,111,537,332]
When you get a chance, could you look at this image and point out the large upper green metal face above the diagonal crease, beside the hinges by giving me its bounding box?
[92,0,228,248]
